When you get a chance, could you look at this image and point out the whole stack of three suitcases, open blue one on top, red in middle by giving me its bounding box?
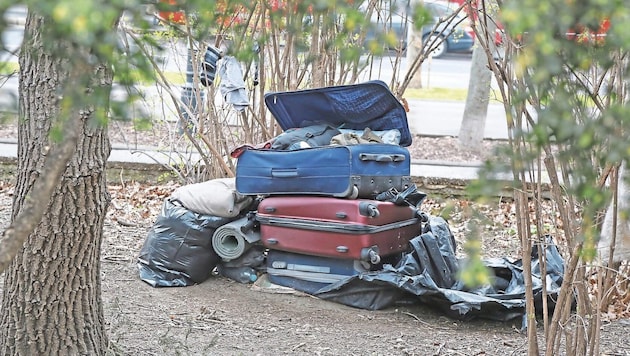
[236,81,421,294]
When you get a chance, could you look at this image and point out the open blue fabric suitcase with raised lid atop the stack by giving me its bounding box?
[236,81,412,199]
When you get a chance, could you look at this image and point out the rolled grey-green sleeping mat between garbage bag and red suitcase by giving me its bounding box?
[212,217,260,261]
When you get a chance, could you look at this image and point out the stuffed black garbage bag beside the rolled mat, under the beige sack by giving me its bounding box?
[138,199,235,287]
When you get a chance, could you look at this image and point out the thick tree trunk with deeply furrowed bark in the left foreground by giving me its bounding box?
[0,9,111,355]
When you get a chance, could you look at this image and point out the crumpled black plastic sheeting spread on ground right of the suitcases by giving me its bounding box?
[314,217,564,321]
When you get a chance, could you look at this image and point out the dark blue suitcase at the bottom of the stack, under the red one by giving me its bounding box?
[267,250,400,294]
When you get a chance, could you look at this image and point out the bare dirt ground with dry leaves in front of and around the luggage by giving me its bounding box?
[0,121,630,356]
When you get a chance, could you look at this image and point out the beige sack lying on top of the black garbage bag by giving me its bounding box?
[171,178,253,218]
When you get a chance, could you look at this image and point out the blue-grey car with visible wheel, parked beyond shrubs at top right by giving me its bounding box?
[361,0,475,58]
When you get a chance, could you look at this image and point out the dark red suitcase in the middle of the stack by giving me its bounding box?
[256,196,421,264]
